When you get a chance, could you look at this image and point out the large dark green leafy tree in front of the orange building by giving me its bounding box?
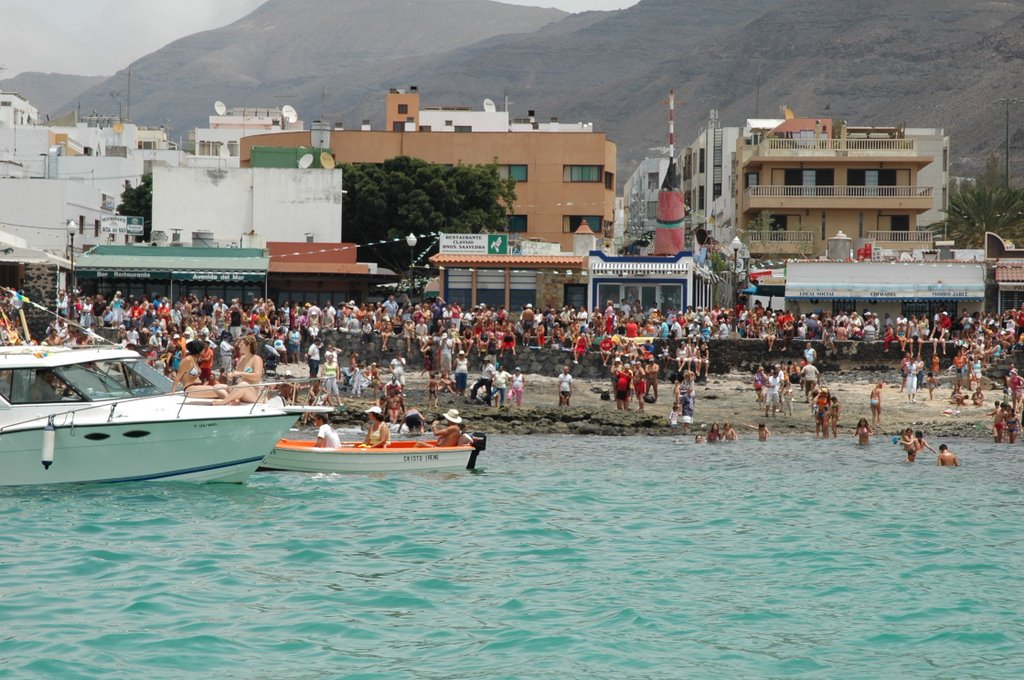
[341,156,516,271]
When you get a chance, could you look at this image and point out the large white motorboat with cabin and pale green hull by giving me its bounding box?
[0,346,297,486]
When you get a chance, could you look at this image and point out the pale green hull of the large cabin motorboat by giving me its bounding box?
[0,408,296,486]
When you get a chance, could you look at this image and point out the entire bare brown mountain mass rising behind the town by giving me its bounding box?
[54,0,1024,178]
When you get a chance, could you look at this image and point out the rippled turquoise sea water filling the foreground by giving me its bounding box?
[0,436,1024,679]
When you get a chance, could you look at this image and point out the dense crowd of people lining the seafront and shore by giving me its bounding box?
[4,284,1024,458]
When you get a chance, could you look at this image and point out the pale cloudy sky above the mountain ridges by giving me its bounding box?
[0,0,639,80]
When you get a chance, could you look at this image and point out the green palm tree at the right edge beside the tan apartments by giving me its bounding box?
[945,184,1024,248]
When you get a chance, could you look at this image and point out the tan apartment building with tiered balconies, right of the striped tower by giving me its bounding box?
[735,117,949,257]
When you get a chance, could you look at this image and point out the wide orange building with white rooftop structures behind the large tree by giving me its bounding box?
[240,89,616,250]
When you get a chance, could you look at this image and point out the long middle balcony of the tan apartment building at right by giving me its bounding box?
[743,184,933,212]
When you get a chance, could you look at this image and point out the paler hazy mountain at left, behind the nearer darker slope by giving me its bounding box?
[66,0,566,135]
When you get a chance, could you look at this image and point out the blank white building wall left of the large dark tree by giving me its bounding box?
[153,167,342,243]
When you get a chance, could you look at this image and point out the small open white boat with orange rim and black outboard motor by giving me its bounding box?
[260,432,487,472]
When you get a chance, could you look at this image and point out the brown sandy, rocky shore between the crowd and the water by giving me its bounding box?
[282,365,1002,438]
